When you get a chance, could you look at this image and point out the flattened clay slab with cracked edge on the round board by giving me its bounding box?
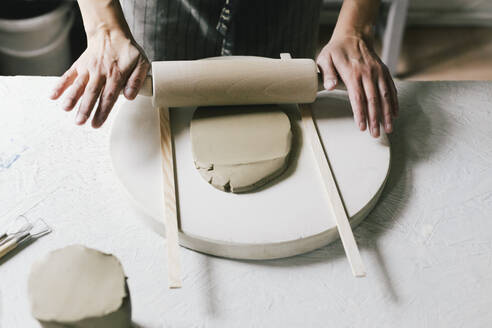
[190,105,292,193]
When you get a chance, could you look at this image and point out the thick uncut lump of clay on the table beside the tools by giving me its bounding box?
[28,245,131,327]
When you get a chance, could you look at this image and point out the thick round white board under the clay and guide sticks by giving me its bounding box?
[110,91,390,259]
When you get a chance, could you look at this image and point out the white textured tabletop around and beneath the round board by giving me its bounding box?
[0,77,492,328]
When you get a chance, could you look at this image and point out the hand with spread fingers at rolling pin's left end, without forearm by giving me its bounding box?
[51,29,150,128]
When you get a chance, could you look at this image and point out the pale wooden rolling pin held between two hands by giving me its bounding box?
[140,57,318,107]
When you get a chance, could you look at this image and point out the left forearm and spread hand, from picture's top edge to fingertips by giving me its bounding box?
[51,0,150,128]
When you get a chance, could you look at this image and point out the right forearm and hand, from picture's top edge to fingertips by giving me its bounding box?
[316,0,398,137]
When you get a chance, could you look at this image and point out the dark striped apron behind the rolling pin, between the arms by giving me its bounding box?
[121,0,321,61]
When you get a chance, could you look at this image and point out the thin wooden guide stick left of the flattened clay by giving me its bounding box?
[157,107,182,288]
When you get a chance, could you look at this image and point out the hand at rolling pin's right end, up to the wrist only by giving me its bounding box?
[316,33,398,137]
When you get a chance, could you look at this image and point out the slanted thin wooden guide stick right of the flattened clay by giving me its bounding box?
[299,104,366,277]
